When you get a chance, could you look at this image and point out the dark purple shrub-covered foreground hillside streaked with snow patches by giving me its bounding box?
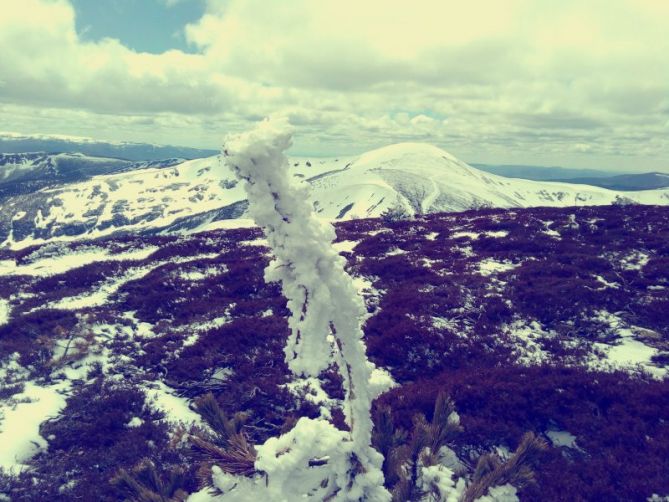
[0,206,669,501]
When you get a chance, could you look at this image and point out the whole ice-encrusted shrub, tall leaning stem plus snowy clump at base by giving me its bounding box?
[214,121,389,500]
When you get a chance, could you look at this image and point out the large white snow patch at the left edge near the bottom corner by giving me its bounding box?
[0,382,69,472]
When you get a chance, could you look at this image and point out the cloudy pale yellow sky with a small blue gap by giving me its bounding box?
[0,0,669,171]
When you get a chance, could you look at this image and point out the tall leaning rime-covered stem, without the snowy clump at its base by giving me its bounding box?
[224,119,390,500]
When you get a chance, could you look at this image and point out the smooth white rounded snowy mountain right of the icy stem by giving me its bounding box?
[312,143,669,218]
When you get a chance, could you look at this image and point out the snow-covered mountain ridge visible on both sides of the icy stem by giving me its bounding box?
[0,143,669,247]
